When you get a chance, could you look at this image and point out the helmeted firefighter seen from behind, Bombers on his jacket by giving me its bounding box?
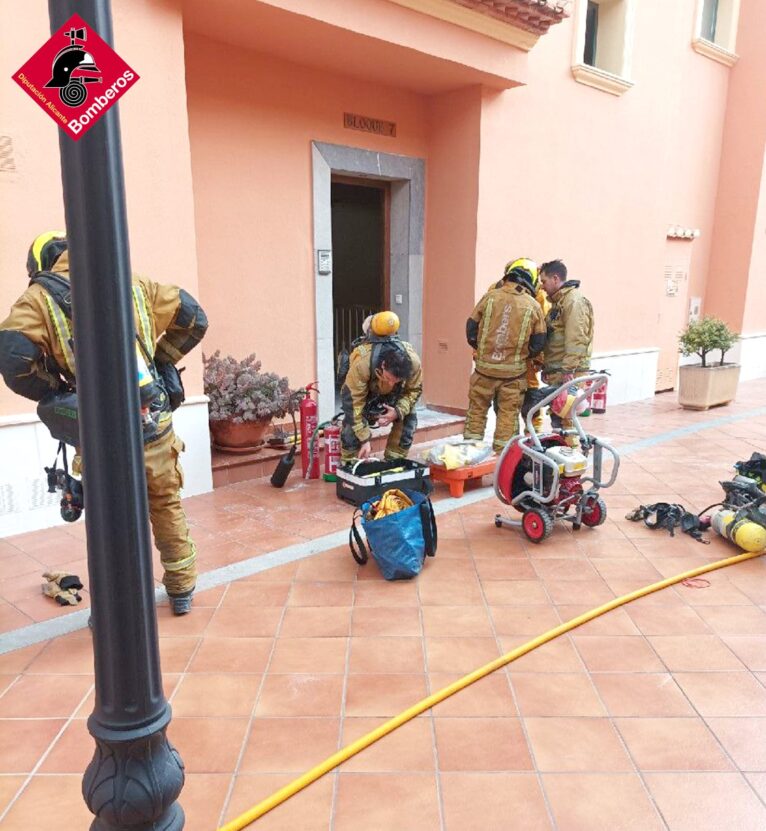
[463,257,545,452]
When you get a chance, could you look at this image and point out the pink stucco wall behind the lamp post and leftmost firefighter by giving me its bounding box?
[0,0,202,415]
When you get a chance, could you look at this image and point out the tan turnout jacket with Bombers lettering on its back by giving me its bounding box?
[466,280,546,378]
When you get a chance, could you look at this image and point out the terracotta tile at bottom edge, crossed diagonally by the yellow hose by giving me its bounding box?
[222,774,335,831]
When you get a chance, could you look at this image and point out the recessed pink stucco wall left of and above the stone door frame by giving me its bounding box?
[186,33,428,394]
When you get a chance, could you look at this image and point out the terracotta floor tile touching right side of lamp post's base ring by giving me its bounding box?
[168,717,248,773]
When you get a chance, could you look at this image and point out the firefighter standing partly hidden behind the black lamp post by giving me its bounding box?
[0,231,207,615]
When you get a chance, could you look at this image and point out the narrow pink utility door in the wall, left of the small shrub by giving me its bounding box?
[654,239,692,392]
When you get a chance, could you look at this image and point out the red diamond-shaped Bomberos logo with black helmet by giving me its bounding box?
[13,15,139,141]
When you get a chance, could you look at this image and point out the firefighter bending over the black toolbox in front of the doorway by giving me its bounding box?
[340,312,423,463]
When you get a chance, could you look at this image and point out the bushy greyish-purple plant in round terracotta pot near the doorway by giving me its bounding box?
[202,350,294,452]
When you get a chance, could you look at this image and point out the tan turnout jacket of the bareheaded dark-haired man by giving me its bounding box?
[543,280,593,375]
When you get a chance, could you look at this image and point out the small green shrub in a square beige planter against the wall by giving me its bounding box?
[678,316,740,410]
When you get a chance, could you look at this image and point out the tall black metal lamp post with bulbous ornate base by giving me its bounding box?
[48,0,184,831]
